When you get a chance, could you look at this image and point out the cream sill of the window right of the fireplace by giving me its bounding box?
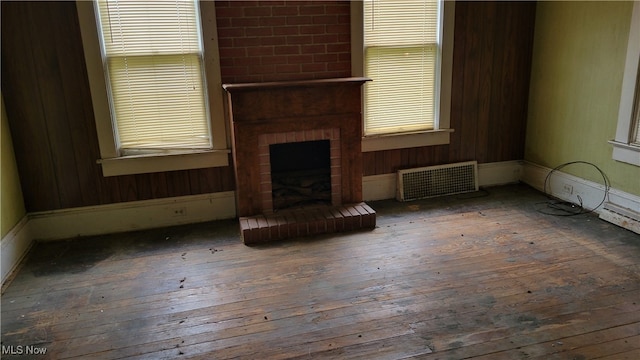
[362,129,454,152]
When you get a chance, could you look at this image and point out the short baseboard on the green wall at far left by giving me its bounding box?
[0,216,33,284]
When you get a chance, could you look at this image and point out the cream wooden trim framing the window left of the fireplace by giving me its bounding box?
[76,0,230,176]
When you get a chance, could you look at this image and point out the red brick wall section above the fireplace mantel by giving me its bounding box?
[216,0,351,83]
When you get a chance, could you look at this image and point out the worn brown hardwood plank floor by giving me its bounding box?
[2,185,640,359]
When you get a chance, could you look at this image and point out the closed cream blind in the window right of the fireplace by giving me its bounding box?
[363,0,439,135]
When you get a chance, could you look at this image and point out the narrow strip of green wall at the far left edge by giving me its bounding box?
[0,94,27,238]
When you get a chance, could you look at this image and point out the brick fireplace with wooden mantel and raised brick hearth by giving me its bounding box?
[223,78,375,244]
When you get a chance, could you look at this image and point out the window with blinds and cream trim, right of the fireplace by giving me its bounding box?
[352,0,455,151]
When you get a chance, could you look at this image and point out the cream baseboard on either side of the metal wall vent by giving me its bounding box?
[362,160,523,201]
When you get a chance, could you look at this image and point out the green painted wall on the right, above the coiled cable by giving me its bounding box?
[525,1,640,196]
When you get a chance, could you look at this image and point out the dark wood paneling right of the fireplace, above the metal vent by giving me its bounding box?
[363,1,536,175]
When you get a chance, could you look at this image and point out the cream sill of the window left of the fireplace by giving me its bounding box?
[98,150,230,176]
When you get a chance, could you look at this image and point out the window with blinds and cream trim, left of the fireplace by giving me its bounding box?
[77,0,228,176]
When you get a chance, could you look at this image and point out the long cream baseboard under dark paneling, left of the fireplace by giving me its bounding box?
[29,191,236,240]
